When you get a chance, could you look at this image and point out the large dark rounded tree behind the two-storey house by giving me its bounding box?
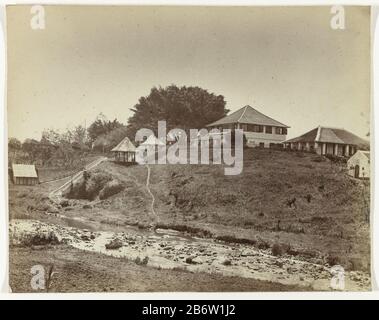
[127,85,229,139]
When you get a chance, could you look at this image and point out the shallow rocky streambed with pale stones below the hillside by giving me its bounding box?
[9,219,370,291]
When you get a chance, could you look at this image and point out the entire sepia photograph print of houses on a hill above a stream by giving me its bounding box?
[5,5,373,292]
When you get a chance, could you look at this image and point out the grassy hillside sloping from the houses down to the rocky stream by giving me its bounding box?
[10,149,370,270]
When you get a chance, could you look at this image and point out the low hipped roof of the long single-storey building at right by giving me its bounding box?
[285,126,369,145]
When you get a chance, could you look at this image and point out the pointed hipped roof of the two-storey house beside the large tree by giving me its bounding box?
[207,106,289,128]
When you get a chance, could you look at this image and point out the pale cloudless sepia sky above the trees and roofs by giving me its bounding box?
[6,6,371,140]
